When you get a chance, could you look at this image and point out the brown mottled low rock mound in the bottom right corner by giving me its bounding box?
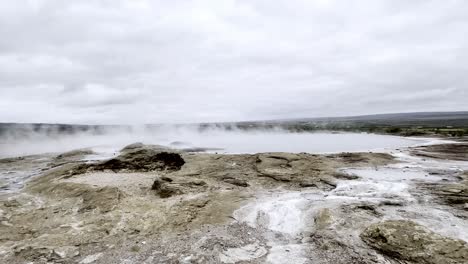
[361,220,468,264]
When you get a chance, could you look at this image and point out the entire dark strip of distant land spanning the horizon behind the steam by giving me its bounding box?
[0,111,468,138]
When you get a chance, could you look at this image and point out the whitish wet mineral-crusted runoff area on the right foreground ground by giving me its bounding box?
[234,146,468,263]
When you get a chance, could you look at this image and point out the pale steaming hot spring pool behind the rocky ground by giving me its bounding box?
[0,129,436,158]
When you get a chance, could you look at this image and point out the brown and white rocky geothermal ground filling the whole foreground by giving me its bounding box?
[0,143,468,264]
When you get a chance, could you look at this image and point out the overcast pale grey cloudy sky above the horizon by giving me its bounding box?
[0,0,468,124]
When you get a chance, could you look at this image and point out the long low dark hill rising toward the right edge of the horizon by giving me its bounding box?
[218,111,468,137]
